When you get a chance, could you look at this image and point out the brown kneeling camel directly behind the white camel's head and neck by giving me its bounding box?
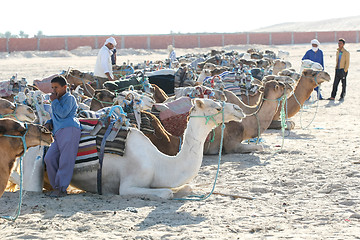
[204,80,292,154]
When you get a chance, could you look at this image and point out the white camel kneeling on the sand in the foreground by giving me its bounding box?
[71,99,245,199]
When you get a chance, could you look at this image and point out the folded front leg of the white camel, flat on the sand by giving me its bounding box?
[119,185,173,199]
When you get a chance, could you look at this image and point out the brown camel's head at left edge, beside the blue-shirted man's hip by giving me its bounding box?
[0,118,54,148]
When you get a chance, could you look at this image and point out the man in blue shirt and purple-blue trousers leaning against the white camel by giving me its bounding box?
[44,76,81,197]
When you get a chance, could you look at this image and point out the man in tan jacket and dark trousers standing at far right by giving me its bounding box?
[328,38,350,101]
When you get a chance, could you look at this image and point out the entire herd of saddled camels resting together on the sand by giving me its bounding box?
[0,49,330,199]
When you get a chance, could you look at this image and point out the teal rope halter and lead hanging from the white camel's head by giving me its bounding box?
[173,102,225,201]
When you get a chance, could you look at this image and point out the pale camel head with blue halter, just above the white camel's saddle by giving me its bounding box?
[114,91,155,111]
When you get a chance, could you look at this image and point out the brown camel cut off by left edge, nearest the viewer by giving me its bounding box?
[0,118,53,197]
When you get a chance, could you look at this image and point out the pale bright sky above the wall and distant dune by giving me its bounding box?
[0,0,360,37]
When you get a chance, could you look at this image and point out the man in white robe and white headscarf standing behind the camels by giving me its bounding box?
[94,37,116,88]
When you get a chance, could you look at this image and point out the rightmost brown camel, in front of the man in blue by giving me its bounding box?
[271,69,330,128]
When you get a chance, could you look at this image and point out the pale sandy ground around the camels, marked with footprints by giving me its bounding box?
[0,44,360,239]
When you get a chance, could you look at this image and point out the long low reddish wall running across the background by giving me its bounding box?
[0,31,360,52]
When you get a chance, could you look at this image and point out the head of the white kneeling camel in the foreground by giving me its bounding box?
[190,98,245,126]
